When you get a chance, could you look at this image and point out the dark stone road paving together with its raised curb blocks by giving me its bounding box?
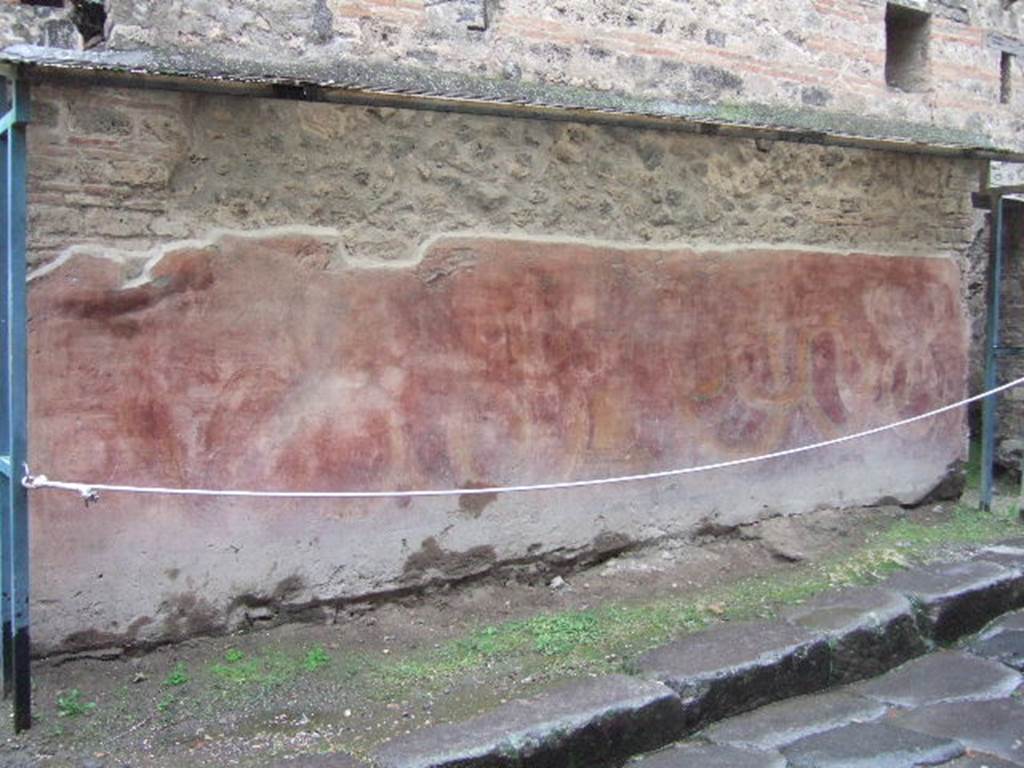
[373,540,1024,768]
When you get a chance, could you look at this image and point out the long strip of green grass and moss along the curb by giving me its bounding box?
[356,505,1020,696]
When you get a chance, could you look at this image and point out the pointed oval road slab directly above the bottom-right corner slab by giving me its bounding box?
[850,651,1021,707]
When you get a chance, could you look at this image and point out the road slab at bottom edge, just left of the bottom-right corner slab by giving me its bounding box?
[782,723,964,768]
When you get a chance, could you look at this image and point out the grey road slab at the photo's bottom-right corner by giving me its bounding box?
[893,698,1024,766]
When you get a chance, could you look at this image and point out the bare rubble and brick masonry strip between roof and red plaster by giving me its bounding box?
[30,86,978,263]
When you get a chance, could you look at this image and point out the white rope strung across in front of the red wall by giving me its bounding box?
[22,377,1024,503]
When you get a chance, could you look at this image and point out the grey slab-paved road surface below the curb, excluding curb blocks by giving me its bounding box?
[628,610,1024,768]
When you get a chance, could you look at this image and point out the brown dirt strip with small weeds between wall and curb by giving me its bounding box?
[0,495,1020,768]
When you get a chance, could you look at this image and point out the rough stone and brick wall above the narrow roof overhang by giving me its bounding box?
[0,0,1024,148]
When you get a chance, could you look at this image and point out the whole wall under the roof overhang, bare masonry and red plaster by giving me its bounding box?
[19,84,978,652]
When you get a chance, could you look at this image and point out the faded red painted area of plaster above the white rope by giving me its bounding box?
[25,237,967,505]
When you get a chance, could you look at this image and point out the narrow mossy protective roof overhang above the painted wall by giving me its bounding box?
[6,45,1024,162]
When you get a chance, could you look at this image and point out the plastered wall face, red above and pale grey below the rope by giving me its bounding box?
[24,233,968,644]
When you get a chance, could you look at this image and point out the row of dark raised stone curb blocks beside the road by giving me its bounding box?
[364,540,1024,768]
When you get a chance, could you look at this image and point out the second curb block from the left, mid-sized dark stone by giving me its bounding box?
[635,623,829,730]
